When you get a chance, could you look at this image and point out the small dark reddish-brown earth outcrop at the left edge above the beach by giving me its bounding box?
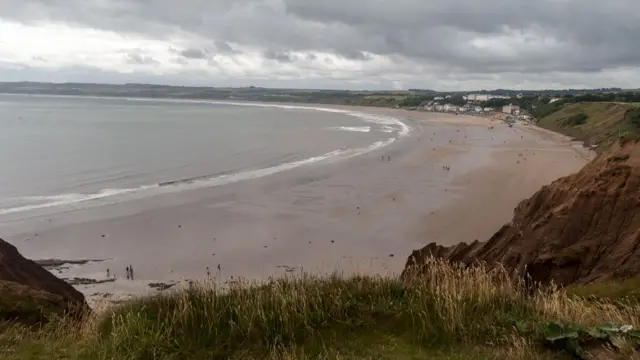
[0,239,89,322]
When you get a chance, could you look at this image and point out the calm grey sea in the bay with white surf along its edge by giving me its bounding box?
[0,94,410,223]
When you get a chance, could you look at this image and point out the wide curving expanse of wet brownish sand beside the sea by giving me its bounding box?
[6,108,587,304]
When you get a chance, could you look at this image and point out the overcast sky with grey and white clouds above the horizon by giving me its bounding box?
[0,0,640,91]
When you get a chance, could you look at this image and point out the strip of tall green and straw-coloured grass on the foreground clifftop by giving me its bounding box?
[0,262,640,359]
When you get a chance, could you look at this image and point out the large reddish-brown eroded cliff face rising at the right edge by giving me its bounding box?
[403,141,640,285]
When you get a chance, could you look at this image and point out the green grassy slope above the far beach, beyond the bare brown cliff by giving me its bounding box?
[538,102,640,152]
